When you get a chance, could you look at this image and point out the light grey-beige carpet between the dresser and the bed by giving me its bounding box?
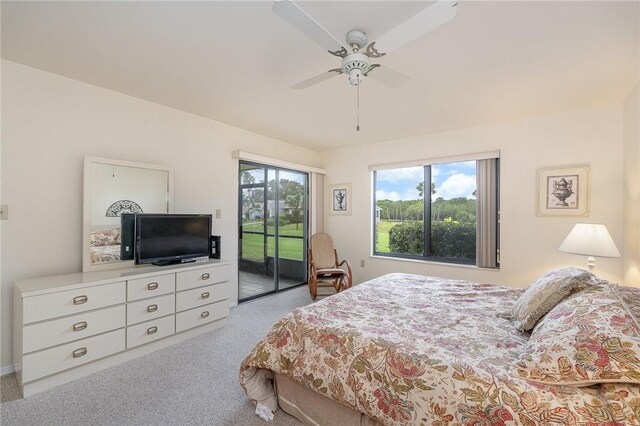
[0,286,311,426]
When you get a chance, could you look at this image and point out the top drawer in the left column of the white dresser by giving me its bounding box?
[22,281,125,324]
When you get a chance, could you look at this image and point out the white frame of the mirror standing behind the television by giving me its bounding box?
[82,155,173,272]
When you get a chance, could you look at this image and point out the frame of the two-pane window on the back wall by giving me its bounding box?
[371,155,500,269]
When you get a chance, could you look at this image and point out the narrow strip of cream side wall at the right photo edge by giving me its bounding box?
[622,86,640,286]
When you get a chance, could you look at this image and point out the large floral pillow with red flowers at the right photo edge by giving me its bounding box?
[510,281,640,386]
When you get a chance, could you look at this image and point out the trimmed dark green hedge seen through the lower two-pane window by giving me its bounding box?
[389,221,476,260]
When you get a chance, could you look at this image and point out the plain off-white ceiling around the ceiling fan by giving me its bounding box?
[1,1,640,150]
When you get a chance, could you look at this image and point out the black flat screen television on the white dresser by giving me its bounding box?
[135,214,211,265]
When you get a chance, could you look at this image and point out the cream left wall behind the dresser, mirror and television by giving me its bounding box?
[0,61,320,367]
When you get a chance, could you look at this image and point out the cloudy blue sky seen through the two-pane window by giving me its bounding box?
[376,161,476,201]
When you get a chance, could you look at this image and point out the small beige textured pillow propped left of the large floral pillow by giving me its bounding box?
[511,268,597,331]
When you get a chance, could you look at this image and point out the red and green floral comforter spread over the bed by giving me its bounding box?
[240,274,640,426]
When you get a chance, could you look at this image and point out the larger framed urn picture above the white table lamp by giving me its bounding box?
[536,165,589,216]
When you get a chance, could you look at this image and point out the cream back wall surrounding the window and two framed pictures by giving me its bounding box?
[323,104,623,287]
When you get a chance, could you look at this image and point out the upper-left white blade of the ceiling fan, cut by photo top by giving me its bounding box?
[272,0,347,52]
